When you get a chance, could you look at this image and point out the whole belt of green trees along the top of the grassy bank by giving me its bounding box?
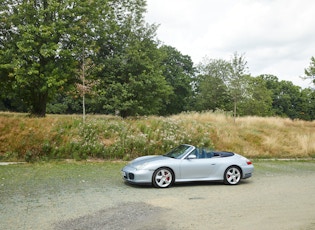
[0,0,315,120]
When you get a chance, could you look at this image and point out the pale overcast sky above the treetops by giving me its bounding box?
[146,0,315,87]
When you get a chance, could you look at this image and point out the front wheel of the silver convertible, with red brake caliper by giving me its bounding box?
[152,168,174,188]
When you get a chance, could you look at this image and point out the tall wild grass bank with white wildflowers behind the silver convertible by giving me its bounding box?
[0,112,315,161]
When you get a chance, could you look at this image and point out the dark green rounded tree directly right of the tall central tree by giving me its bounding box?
[160,45,195,115]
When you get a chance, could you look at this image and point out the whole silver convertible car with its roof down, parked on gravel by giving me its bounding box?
[121,145,254,188]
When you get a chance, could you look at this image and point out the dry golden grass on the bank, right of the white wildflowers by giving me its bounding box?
[174,113,315,158]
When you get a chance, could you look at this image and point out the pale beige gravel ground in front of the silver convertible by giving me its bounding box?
[0,162,315,230]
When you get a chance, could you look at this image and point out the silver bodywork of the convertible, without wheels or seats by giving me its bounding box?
[122,145,254,184]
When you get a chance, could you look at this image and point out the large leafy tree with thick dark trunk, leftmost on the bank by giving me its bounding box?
[0,0,72,116]
